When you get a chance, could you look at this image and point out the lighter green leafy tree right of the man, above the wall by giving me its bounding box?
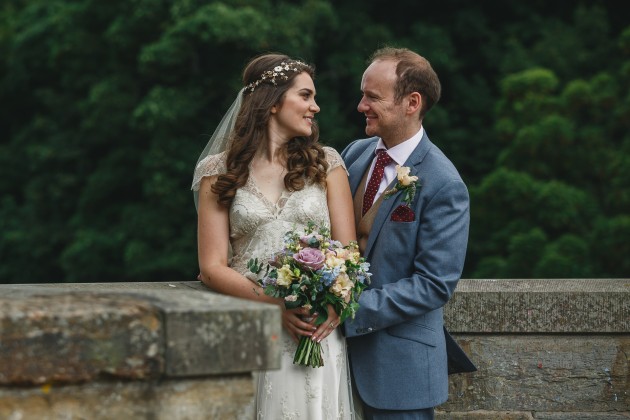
[471,21,630,278]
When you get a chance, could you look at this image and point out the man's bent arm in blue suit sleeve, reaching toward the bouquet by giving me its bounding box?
[346,179,470,337]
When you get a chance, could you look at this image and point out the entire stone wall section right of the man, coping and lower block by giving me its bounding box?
[436,279,630,420]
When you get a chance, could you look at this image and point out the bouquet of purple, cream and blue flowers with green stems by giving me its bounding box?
[247,222,371,367]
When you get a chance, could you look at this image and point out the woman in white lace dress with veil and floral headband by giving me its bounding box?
[192,54,356,420]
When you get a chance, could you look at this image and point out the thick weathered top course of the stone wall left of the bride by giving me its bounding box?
[0,282,280,385]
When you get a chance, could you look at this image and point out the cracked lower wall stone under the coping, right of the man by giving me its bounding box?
[440,334,630,413]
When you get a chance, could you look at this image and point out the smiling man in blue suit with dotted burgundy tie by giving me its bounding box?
[342,48,474,420]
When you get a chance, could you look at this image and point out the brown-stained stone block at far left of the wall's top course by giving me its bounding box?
[0,289,164,384]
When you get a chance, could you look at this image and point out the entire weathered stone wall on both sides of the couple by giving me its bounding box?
[0,279,630,420]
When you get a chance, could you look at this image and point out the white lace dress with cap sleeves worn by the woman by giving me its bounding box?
[193,147,354,420]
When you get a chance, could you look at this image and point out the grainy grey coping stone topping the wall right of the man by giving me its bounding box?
[444,279,630,334]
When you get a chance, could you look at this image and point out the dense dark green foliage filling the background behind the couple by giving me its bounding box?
[0,0,630,283]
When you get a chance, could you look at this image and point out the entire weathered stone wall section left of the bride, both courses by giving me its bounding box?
[0,282,280,420]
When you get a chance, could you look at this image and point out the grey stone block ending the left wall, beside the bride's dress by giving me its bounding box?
[156,291,282,377]
